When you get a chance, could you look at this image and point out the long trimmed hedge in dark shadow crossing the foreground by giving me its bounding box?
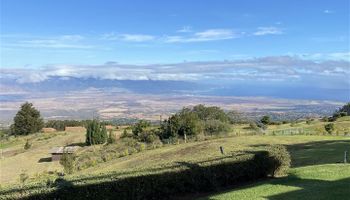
[0,145,290,200]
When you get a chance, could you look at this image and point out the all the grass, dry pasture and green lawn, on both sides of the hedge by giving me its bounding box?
[1,118,350,199]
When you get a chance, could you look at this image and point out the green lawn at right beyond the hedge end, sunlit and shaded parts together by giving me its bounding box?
[200,134,350,200]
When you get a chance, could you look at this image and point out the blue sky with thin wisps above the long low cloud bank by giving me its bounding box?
[1,0,349,68]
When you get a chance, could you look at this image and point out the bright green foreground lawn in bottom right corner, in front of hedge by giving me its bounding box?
[200,164,350,200]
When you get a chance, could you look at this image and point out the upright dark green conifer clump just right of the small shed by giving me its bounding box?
[86,120,107,145]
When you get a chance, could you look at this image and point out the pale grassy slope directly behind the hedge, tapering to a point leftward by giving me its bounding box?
[76,135,350,175]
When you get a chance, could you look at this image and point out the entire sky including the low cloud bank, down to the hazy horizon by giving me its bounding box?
[0,0,350,101]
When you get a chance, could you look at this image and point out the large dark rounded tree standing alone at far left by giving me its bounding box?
[12,102,44,135]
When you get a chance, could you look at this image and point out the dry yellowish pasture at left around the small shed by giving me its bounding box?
[0,132,85,184]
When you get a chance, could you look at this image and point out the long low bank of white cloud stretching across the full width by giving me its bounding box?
[1,54,350,83]
